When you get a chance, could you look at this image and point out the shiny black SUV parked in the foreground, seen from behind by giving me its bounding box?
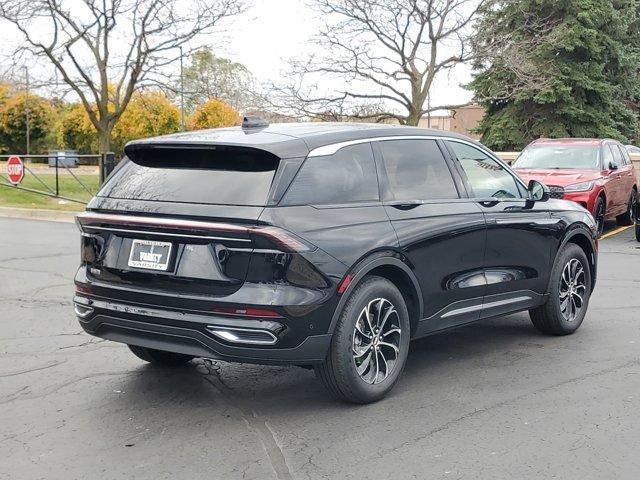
[74,120,597,403]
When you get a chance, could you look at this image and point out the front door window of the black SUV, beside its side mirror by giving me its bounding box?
[449,142,522,198]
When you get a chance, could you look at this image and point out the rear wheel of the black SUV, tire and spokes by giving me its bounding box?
[315,276,410,404]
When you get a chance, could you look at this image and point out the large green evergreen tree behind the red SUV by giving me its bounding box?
[470,0,640,150]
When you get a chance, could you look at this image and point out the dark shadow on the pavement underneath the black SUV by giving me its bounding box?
[111,313,553,413]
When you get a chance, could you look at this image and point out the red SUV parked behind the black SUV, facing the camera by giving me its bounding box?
[513,138,638,233]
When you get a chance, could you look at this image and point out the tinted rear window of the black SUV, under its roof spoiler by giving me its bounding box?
[98,147,278,206]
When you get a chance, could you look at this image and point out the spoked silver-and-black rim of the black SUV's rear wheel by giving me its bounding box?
[352,298,402,385]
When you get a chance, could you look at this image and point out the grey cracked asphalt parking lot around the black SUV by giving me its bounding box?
[0,219,640,480]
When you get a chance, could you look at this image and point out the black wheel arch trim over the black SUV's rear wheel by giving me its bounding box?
[329,252,423,335]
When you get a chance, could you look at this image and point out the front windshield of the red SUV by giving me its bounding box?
[513,145,600,170]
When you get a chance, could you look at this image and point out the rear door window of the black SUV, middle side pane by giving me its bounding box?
[380,140,458,201]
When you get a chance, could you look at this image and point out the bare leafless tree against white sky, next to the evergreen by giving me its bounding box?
[275,0,485,125]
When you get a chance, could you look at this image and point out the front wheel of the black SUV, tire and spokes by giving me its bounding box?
[529,243,591,335]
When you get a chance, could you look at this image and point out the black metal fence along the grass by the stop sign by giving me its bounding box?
[0,152,116,205]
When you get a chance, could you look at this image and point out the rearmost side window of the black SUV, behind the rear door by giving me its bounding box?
[283,143,379,205]
